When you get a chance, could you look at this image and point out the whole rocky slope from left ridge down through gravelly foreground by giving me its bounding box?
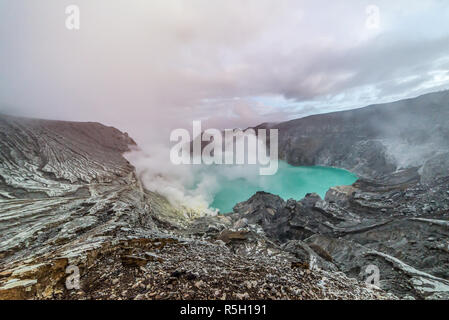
[0,116,388,299]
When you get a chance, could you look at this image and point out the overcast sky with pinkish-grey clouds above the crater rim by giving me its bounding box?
[0,0,449,143]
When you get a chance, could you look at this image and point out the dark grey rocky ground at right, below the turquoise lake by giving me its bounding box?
[230,169,449,299]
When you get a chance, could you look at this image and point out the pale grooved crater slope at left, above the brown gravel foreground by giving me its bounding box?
[0,116,189,298]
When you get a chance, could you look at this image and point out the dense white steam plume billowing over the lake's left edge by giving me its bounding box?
[125,131,274,216]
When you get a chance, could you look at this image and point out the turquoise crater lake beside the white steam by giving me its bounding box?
[211,161,357,213]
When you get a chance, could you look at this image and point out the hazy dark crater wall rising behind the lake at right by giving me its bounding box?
[257,91,449,178]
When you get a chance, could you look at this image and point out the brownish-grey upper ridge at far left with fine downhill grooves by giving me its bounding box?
[0,116,135,199]
